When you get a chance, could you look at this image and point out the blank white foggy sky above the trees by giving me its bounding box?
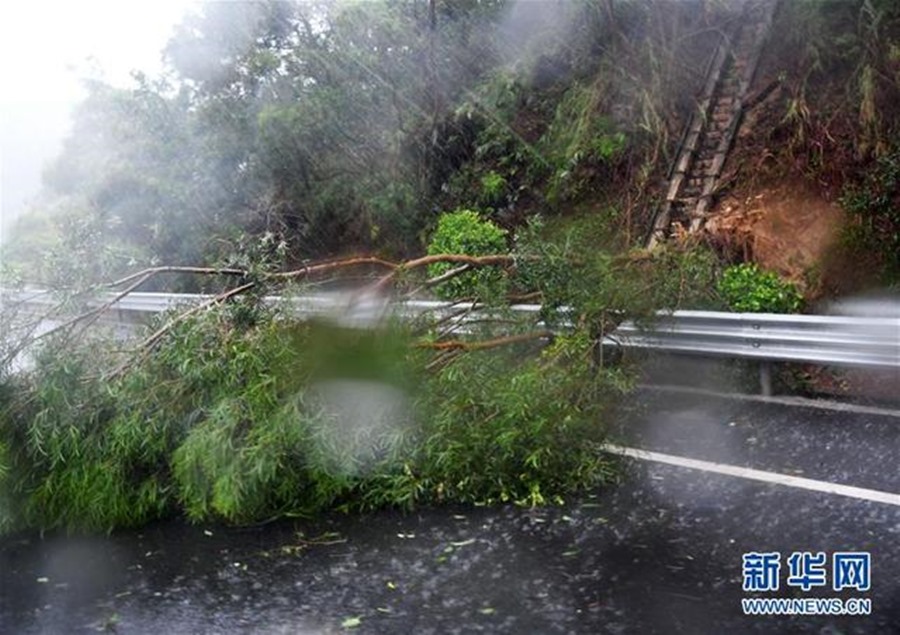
[0,0,197,241]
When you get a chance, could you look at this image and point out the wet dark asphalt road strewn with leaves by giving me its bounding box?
[0,391,900,634]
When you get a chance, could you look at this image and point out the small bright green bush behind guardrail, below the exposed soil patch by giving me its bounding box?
[717,263,803,313]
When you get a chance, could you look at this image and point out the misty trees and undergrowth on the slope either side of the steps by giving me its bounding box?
[7,0,900,288]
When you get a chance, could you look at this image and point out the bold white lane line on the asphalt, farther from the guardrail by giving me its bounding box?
[603,443,900,507]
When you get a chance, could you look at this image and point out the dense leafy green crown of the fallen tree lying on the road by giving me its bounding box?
[0,296,610,531]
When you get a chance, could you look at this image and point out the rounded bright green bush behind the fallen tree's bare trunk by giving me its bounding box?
[428,209,508,300]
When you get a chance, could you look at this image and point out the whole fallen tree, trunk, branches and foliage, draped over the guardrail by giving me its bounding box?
[0,229,713,530]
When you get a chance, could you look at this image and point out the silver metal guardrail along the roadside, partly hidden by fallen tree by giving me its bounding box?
[3,291,900,392]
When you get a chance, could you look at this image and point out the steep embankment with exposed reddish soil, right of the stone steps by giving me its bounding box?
[712,0,900,298]
